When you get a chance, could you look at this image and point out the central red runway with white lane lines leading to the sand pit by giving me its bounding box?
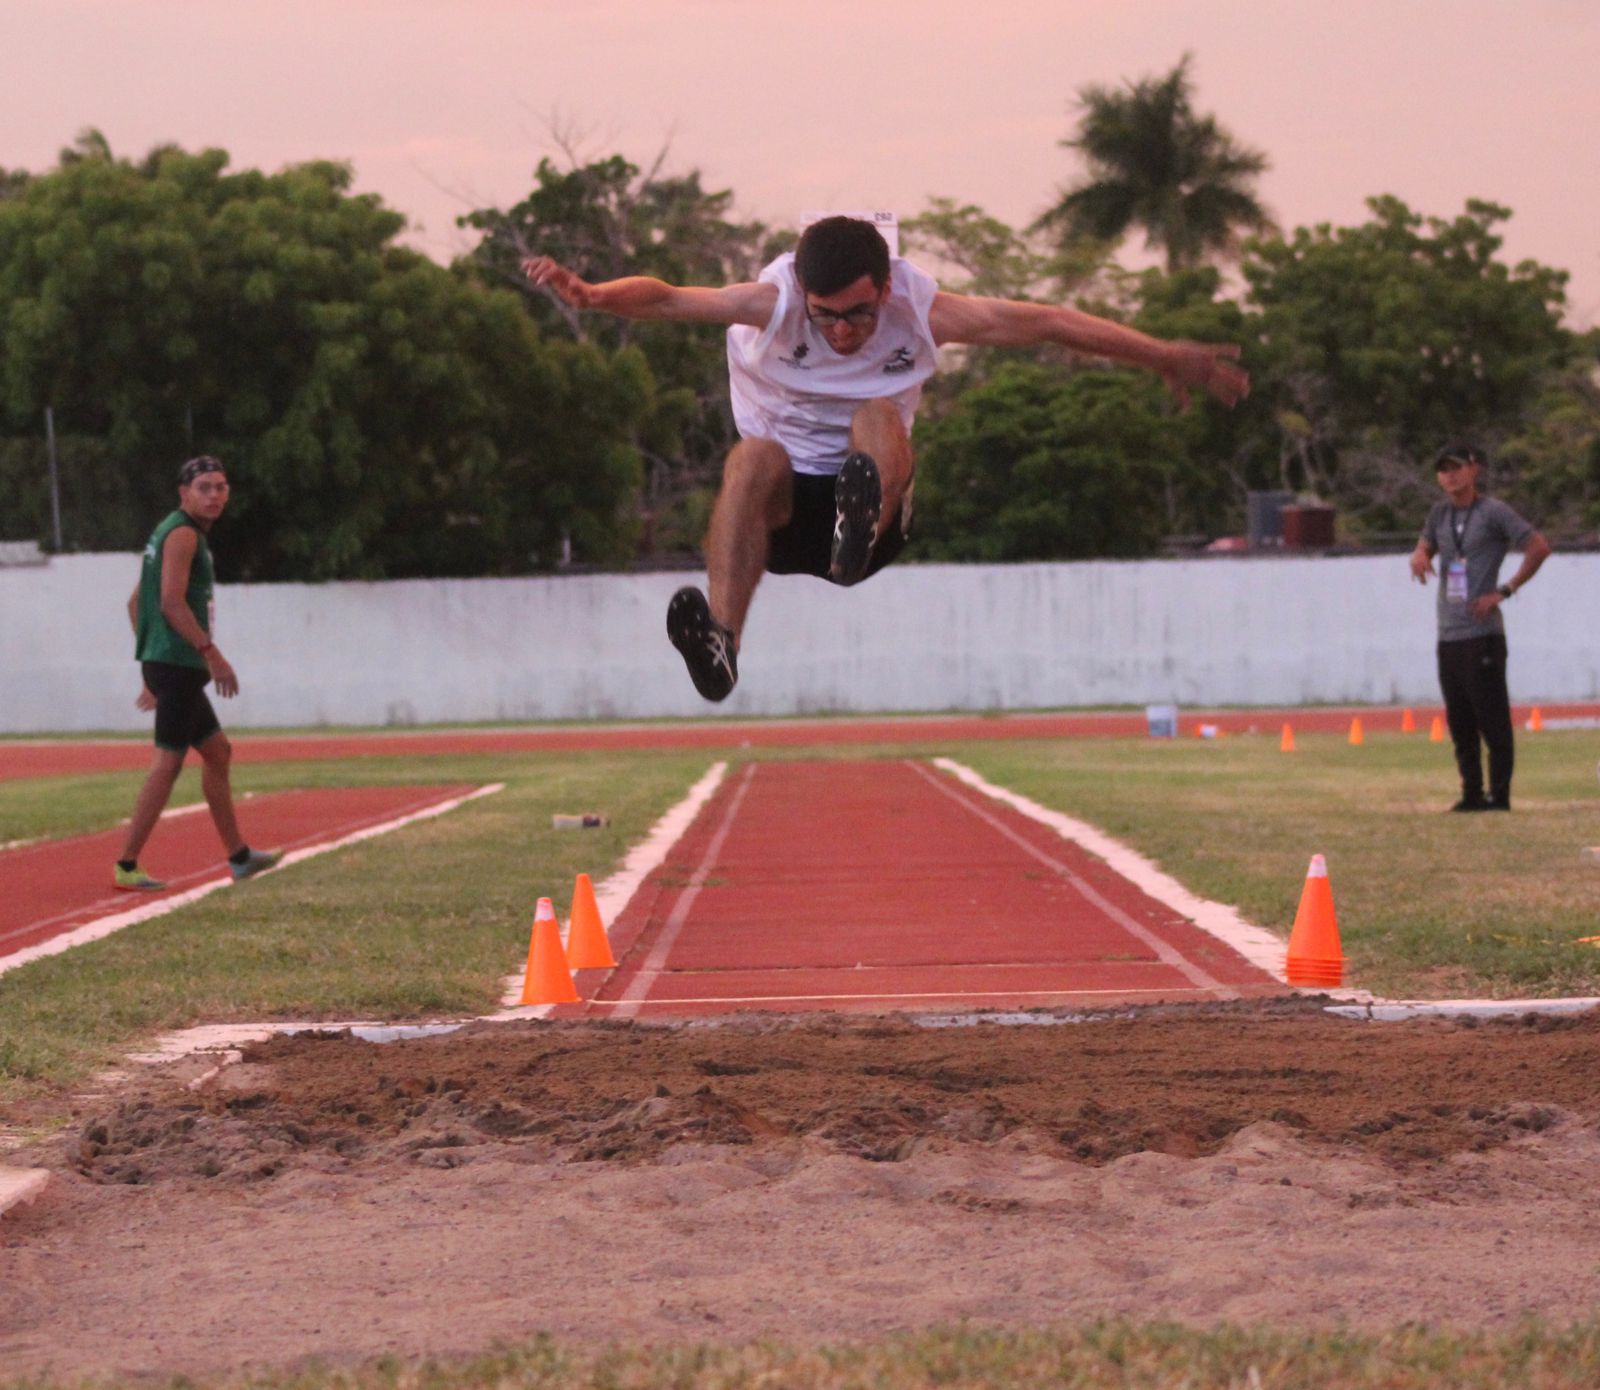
[582,760,1286,1017]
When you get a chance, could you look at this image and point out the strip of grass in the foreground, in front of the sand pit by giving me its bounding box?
[3,1323,1600,1390]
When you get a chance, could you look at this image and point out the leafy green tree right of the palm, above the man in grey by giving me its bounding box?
[1242,197,1573,531]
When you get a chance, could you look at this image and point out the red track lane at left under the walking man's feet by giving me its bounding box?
[0,785,472,961]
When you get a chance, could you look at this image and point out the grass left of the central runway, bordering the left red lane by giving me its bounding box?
[0,753,707,1105]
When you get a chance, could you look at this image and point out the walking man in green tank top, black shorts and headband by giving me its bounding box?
[114,456,283,893]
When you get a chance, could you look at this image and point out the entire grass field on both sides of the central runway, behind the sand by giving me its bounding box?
[0,729,1600,1112]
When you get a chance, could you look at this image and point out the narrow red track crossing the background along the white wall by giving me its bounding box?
[0,704,1600,782]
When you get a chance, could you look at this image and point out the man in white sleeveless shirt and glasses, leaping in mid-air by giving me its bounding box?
[523,218,1250,701]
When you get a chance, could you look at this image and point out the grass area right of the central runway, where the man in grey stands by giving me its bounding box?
[962,729,1600,998]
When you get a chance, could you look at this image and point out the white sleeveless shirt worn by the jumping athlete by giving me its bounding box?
[728,251,939,473]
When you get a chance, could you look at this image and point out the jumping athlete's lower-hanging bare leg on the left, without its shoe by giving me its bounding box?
[706,440,795,649]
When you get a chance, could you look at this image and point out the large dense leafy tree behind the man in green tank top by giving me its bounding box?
[0,139,654,579]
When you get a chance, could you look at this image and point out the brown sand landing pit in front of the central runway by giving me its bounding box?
[0,1001,1600,1377]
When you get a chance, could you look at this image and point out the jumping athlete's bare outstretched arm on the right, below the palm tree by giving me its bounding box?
[928,290,1250,406]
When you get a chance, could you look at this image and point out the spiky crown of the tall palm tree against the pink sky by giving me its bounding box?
[1034,53,1272,272]
